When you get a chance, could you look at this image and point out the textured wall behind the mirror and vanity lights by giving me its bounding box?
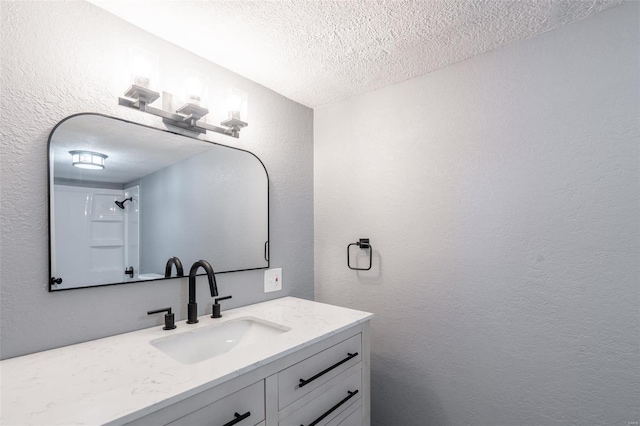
[0,2,313,358]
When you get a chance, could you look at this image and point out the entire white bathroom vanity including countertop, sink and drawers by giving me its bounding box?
[0,297,373,426]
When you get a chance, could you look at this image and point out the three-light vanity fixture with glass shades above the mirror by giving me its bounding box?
[118,49,248,138]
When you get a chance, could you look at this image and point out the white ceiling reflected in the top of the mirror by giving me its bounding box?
[50,115,215,184]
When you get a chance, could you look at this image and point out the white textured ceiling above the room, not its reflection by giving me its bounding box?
[90,0,622,107]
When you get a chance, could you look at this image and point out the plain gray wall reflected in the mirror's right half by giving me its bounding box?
[140,146,269,274]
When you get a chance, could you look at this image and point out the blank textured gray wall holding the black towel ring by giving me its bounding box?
[314,3,640,426]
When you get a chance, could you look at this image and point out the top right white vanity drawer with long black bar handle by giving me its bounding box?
[278,334,362,410]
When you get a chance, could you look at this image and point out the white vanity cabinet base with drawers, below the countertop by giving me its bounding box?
[124,322,370,426]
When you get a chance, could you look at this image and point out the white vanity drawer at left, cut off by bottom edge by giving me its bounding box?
[169,380,264,426]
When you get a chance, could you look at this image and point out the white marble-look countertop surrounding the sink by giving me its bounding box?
[0,297,373,425]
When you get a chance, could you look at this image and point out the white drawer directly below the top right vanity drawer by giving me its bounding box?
[279,369,362,426]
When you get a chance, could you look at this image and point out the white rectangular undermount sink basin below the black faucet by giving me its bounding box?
[150,318,290,364]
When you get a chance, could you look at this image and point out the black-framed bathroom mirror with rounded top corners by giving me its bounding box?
[49,113,269,291]
